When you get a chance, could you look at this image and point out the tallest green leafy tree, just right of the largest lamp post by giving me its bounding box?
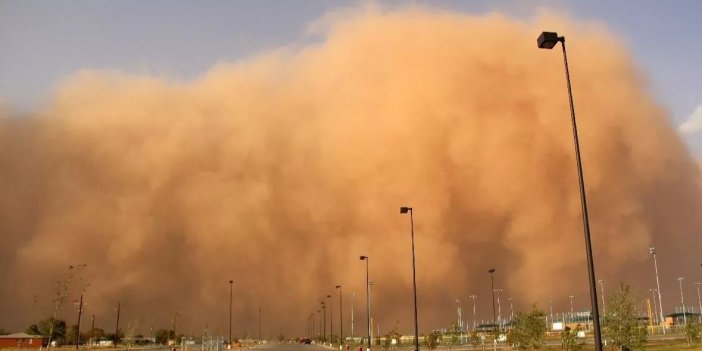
[602,283,648,350]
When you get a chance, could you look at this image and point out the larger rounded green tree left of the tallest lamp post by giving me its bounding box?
[507,305,546,350]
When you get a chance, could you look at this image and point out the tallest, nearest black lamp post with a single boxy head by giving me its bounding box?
[536,32,602,351]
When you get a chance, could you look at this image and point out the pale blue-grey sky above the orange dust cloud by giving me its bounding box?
[0,0,702,156]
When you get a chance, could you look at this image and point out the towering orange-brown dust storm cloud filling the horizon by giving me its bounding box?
[0,9,702,336]
